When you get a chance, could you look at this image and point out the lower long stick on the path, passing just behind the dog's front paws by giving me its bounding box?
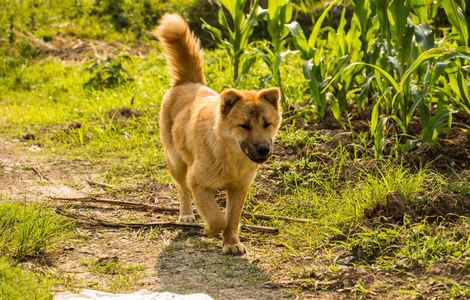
[55,207,279,234]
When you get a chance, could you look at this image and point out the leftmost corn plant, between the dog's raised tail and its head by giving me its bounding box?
[202,0,264,85]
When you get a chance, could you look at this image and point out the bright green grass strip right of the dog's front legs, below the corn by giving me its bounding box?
[247,161,444,253]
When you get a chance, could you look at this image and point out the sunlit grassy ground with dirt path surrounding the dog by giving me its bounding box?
[0,1,470,299]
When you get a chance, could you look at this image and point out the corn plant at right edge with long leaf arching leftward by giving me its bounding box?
[322,47,470,156]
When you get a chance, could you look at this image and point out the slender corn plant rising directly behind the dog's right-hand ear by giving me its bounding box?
[258,0,293,110]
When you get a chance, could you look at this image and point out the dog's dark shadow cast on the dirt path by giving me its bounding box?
[156,232,286,299]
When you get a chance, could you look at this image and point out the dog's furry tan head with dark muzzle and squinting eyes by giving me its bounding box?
[218,88,281,163]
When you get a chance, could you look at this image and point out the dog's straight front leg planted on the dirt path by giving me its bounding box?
[224,186,248,255]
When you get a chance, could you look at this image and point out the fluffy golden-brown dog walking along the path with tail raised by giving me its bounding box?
[154,14,281,255]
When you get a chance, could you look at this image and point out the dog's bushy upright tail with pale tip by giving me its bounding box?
[153,14,206,86]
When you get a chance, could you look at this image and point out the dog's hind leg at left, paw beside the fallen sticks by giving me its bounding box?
[166,151,196,223]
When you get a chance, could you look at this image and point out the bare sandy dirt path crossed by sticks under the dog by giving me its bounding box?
[0,139,289,299]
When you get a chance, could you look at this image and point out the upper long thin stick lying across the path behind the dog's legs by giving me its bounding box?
[49,196,314,223]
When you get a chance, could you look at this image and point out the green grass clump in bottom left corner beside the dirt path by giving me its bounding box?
[0,202,73,300]
